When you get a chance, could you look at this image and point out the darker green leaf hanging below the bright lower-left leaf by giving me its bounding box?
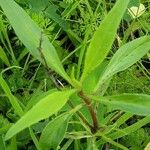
[39,114,70,150]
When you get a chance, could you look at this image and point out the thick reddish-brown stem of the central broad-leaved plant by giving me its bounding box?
[79,91,99,133]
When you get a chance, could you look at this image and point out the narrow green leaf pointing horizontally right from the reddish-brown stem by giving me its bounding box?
[91,94,150,116]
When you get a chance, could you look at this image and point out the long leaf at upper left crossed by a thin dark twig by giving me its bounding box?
[0,0,71,83]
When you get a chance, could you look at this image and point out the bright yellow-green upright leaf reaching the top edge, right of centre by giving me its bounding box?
[81,0,129,81]
